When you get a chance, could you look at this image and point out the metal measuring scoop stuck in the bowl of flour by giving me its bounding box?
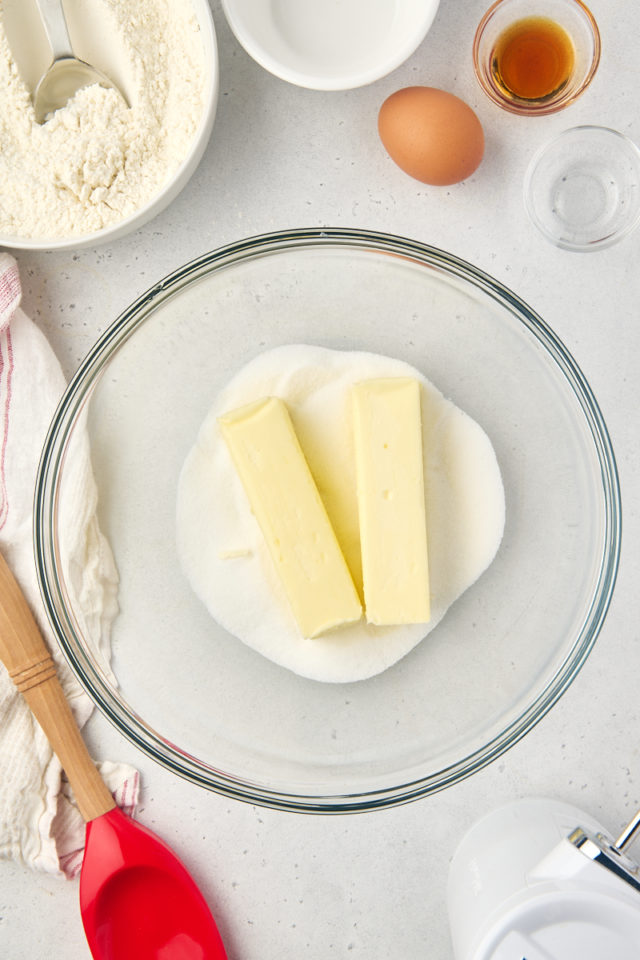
[33,0,129,123]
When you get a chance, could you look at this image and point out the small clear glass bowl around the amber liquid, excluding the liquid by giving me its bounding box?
[473,0,600,117]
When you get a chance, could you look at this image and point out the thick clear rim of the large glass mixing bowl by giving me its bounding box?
[33,227,621,813]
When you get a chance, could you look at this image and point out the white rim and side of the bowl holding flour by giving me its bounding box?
[0,0,219,250]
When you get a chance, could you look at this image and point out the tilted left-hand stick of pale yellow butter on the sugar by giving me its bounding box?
[218,397,362,637]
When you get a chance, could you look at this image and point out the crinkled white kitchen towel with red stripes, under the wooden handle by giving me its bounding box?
[0,253,139,877]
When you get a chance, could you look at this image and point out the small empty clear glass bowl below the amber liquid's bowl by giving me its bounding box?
[524,126,640,251]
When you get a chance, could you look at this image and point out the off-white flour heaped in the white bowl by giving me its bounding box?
[0,0,206,238]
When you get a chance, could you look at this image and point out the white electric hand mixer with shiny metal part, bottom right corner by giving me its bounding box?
[448,799,640,960]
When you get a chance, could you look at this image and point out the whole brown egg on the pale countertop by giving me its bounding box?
[378,87,484,186]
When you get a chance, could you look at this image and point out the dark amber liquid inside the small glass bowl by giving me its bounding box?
[491,17,575,100]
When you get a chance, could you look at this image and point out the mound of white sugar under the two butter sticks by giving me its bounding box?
[177,344,505,683]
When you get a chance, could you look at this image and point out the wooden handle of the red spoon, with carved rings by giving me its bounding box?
[0,555,116,822]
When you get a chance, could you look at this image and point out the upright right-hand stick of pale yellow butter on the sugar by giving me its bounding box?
[352,377,431,625]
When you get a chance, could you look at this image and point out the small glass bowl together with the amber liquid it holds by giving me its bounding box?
[473,0,600,116]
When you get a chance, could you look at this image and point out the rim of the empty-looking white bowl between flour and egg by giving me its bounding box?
[221,0,440,91]
